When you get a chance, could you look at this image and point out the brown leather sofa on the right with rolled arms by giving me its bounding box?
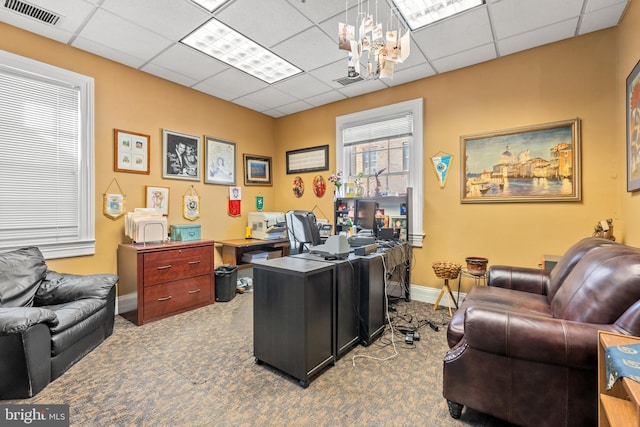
[443,237,640,427]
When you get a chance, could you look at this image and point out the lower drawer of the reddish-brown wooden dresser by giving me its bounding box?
[144,275,212,320]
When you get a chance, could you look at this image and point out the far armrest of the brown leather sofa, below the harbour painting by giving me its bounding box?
[487,265,549,295]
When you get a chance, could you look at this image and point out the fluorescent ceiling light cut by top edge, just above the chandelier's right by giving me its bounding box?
[392,0,485,30]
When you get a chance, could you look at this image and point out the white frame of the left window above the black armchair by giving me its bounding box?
[0,50,96,259]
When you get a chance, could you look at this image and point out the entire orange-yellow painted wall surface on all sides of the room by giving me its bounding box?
[0,0,640,291]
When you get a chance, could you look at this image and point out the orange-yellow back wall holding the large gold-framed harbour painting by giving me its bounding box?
[276,29,625,290]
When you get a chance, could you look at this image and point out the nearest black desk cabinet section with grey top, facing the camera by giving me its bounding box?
[253,257,335,387]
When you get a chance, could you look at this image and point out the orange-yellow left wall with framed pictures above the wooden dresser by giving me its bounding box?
[0,23,275,274]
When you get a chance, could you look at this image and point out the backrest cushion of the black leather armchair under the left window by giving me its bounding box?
[0,247,47,307]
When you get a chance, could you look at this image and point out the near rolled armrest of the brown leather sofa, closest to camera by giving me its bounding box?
[464,307,623,370]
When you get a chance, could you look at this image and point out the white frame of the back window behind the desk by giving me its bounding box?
[336,98,424,247]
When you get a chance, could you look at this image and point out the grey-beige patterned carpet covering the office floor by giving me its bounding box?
[3,293,509,427]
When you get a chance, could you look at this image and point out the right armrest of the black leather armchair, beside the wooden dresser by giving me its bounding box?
[35,270,118,306]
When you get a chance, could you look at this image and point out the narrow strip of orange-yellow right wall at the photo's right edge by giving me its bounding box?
[615,2,640,246]
